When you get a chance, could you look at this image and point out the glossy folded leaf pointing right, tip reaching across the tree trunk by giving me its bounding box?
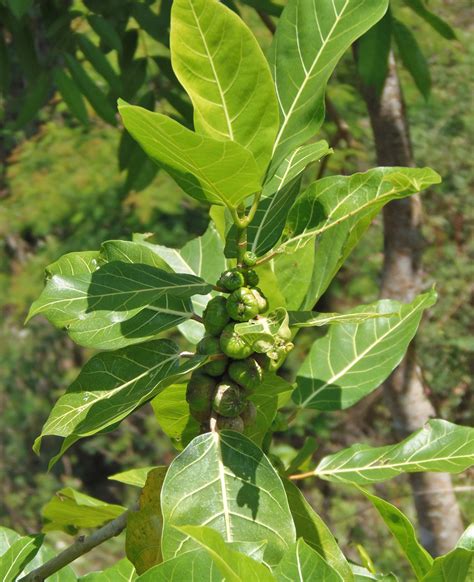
[279,168,441,256]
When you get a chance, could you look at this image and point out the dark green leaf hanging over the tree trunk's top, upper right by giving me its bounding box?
[357,10,392,95]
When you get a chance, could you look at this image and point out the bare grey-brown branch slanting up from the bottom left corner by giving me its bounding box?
[20,507,135,582]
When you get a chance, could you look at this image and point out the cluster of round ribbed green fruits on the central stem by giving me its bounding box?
[186,252,288,432]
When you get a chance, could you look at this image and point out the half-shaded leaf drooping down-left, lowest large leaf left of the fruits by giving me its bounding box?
[34,340,205,451]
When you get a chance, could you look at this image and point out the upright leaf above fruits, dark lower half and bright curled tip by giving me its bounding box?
[226,141,332,257]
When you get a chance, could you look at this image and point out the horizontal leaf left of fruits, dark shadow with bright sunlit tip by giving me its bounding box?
[27,261,211,327]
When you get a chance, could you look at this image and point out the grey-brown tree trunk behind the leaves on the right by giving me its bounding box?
[362,54,463,556]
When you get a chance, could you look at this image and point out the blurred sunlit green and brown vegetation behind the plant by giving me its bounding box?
[0,0,474,573]
